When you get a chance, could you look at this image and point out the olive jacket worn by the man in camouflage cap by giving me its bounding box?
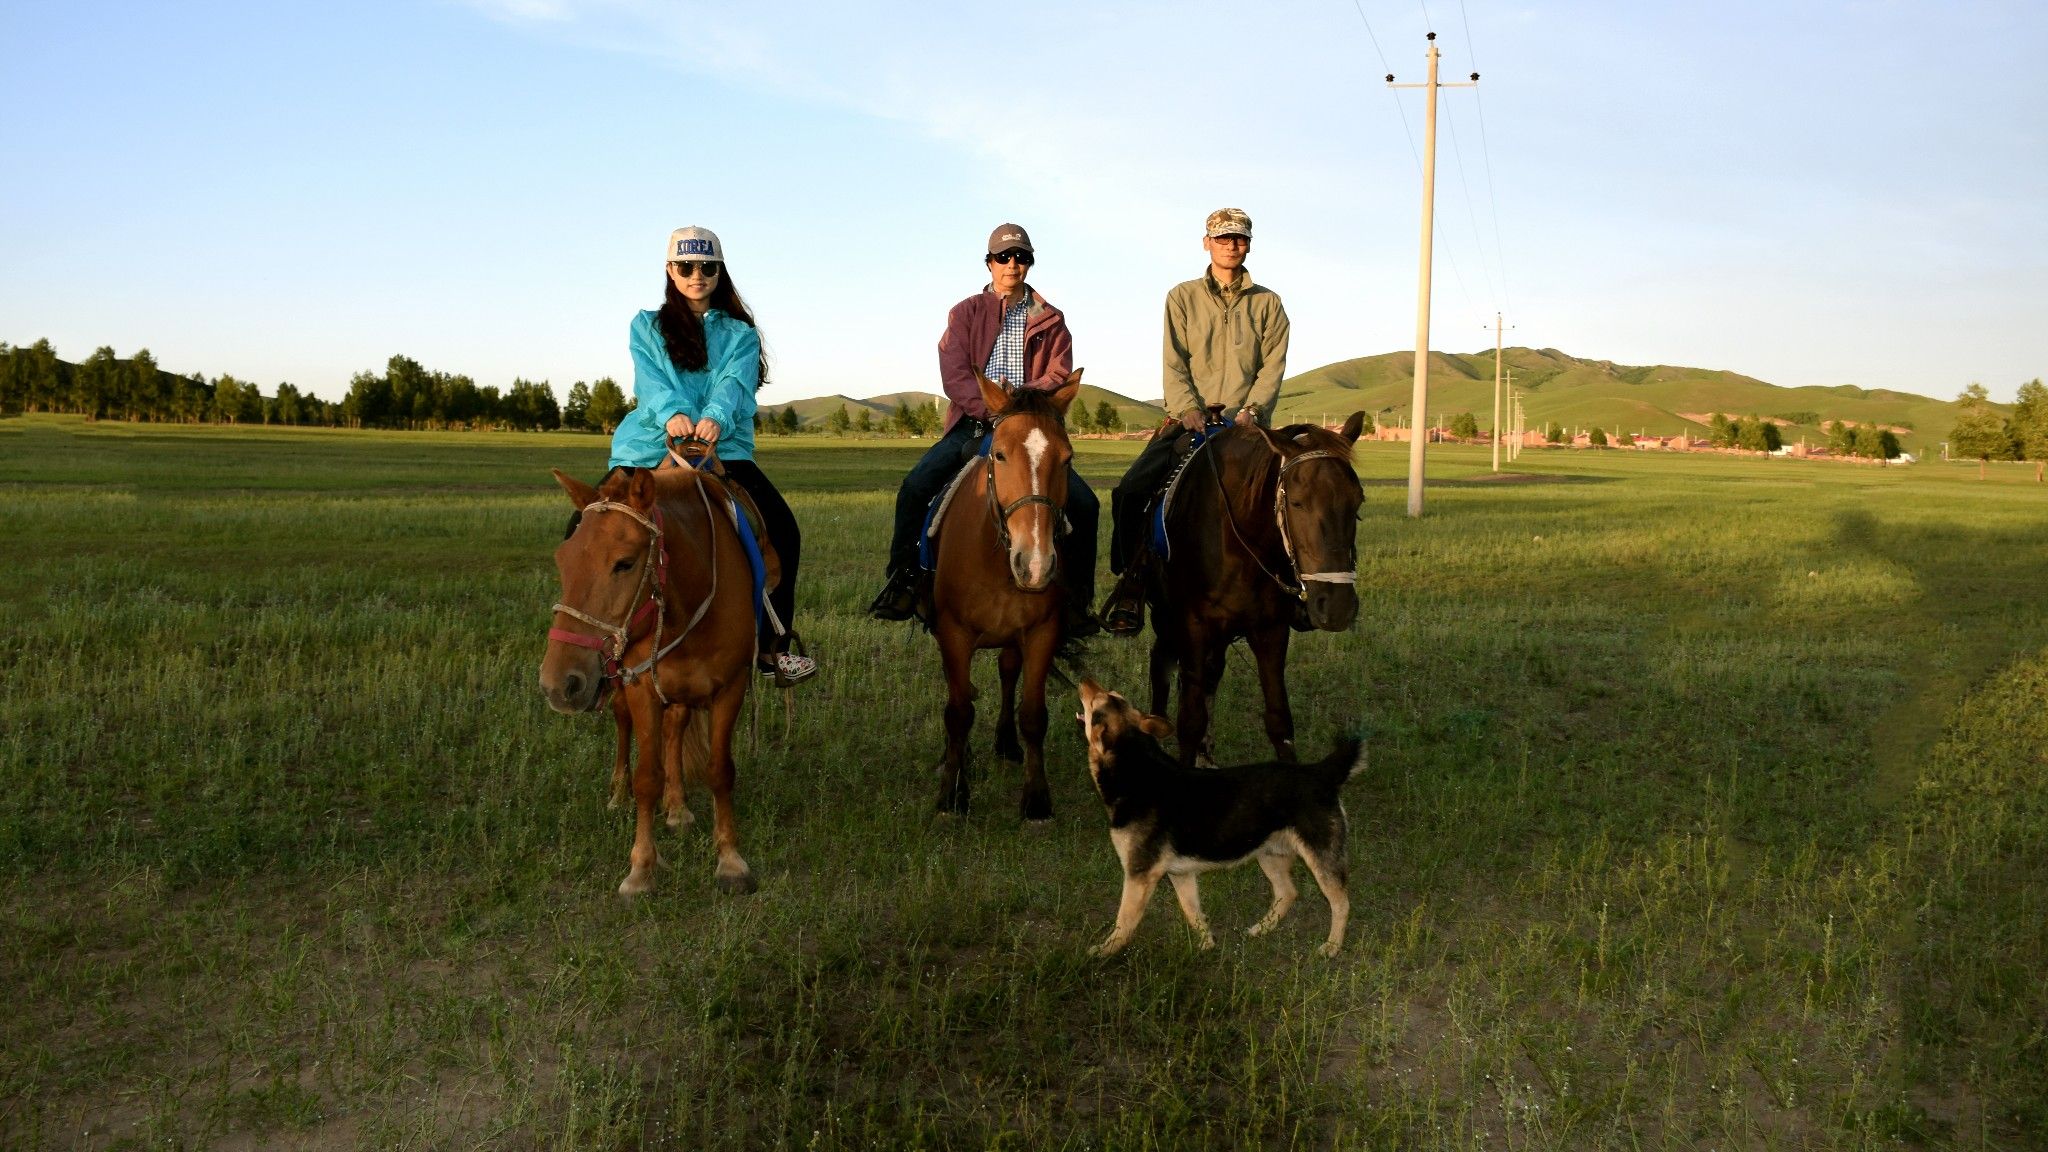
[1165,269,1288,422]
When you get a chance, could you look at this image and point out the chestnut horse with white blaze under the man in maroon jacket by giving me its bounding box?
[926,369,1081,820]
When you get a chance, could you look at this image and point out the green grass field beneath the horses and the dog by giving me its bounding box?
[0,418,2048,1150]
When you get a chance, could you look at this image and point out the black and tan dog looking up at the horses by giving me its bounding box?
[1081,678,1364,955]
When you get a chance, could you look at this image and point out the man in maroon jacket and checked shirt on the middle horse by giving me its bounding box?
[868,223,1102,637]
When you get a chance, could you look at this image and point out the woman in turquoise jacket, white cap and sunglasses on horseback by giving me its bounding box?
[612,228,817,685]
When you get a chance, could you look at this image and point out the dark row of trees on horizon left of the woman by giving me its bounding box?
[0,340,633,433]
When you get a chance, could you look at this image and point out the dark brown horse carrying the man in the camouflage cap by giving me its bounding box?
[1147,412,1366,765]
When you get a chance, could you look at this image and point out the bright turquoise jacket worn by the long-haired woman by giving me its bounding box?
[612,307,762,467]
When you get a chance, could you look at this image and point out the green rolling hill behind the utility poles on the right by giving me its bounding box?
[1280,348,2007,451]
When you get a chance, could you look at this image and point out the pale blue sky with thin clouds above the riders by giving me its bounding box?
[0,0,2048,400]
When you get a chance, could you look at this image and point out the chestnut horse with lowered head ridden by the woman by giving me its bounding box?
[541,467,774,896]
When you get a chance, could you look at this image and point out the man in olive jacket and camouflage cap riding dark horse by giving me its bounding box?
[1102,207,1288,635]
